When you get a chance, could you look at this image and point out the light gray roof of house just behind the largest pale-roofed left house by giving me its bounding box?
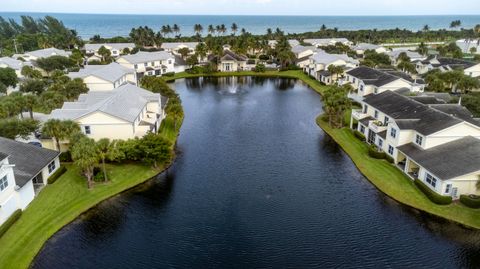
[68,62,135,83]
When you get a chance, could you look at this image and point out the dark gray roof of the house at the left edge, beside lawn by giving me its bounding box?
[0,137,60,187]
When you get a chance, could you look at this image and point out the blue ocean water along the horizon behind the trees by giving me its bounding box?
[0,12,480,39]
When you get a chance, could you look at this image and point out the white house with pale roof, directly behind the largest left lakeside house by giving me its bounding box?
[68,63,137,91]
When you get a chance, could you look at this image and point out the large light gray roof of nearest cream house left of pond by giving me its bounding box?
[49,83,160,122]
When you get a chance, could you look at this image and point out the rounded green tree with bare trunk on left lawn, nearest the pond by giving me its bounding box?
[71,137,99,189]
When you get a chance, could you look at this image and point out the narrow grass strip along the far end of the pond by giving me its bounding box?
[165,70,325,94]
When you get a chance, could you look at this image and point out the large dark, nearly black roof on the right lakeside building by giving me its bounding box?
[363,91,464,135]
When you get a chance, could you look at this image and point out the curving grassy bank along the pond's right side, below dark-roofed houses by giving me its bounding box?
[317,117,480,229]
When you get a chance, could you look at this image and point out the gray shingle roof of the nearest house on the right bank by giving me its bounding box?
[398,136,480,180]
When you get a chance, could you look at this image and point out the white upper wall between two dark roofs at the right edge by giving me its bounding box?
[424,122,480,149]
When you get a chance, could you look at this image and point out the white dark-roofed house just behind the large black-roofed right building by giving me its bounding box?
[343,66,425,102]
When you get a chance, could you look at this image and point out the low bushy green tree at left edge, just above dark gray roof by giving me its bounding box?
[0,118,39,139]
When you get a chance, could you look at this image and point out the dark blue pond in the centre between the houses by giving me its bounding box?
[31,77,480,268]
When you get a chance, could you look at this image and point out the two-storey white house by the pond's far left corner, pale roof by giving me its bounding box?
[116,51,175,78]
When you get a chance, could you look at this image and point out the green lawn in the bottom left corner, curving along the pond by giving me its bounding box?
[0,164,161,268]
